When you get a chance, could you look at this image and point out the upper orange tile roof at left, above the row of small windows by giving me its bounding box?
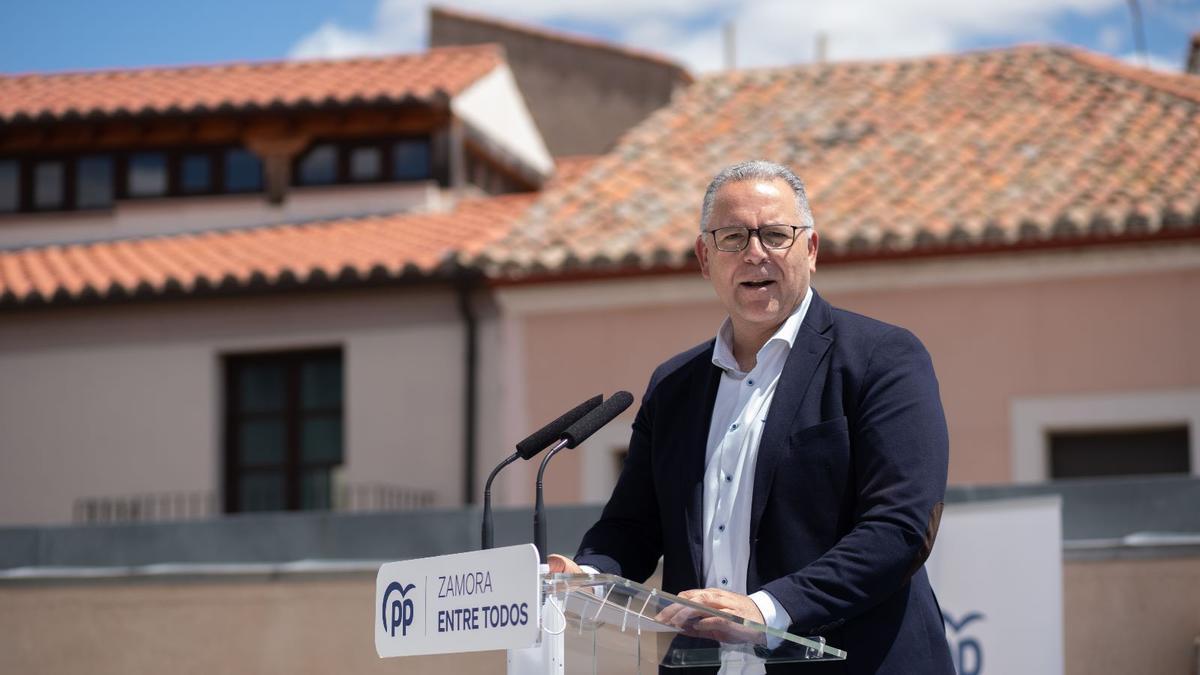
[0,44,504,124]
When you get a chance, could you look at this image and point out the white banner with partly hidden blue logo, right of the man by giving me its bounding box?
[921,496,1063,675]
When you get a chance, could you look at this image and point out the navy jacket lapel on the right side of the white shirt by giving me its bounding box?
[748,291,833,540]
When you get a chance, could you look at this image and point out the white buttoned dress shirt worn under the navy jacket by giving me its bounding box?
[704,288,812,629]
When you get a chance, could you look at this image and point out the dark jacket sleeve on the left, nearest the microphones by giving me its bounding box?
[575,374,662,581]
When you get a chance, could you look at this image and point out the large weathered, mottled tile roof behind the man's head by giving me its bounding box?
[473,47,1200,276]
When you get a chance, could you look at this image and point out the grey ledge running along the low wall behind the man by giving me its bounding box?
[0,477,1200,571]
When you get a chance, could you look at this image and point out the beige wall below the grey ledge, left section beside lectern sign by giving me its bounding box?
[0,575,505,675]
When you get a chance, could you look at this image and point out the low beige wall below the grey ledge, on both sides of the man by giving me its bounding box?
[0,557,1200,675]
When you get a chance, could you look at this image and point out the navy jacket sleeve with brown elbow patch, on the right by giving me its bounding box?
[763,328,949,634]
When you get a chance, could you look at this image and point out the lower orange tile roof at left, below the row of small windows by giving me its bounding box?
[0,193,534,306]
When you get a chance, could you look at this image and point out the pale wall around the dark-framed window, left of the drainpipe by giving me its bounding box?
[0,284,463,525]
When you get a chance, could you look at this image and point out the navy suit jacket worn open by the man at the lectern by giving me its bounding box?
[576,293,954,674]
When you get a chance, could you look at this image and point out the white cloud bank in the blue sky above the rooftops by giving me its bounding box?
[290,0,1124,72]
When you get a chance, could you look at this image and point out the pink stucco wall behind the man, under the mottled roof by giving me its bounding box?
[523,260,1200,502]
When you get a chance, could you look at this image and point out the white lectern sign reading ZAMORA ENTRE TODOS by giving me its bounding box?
[374,544,541,657]
